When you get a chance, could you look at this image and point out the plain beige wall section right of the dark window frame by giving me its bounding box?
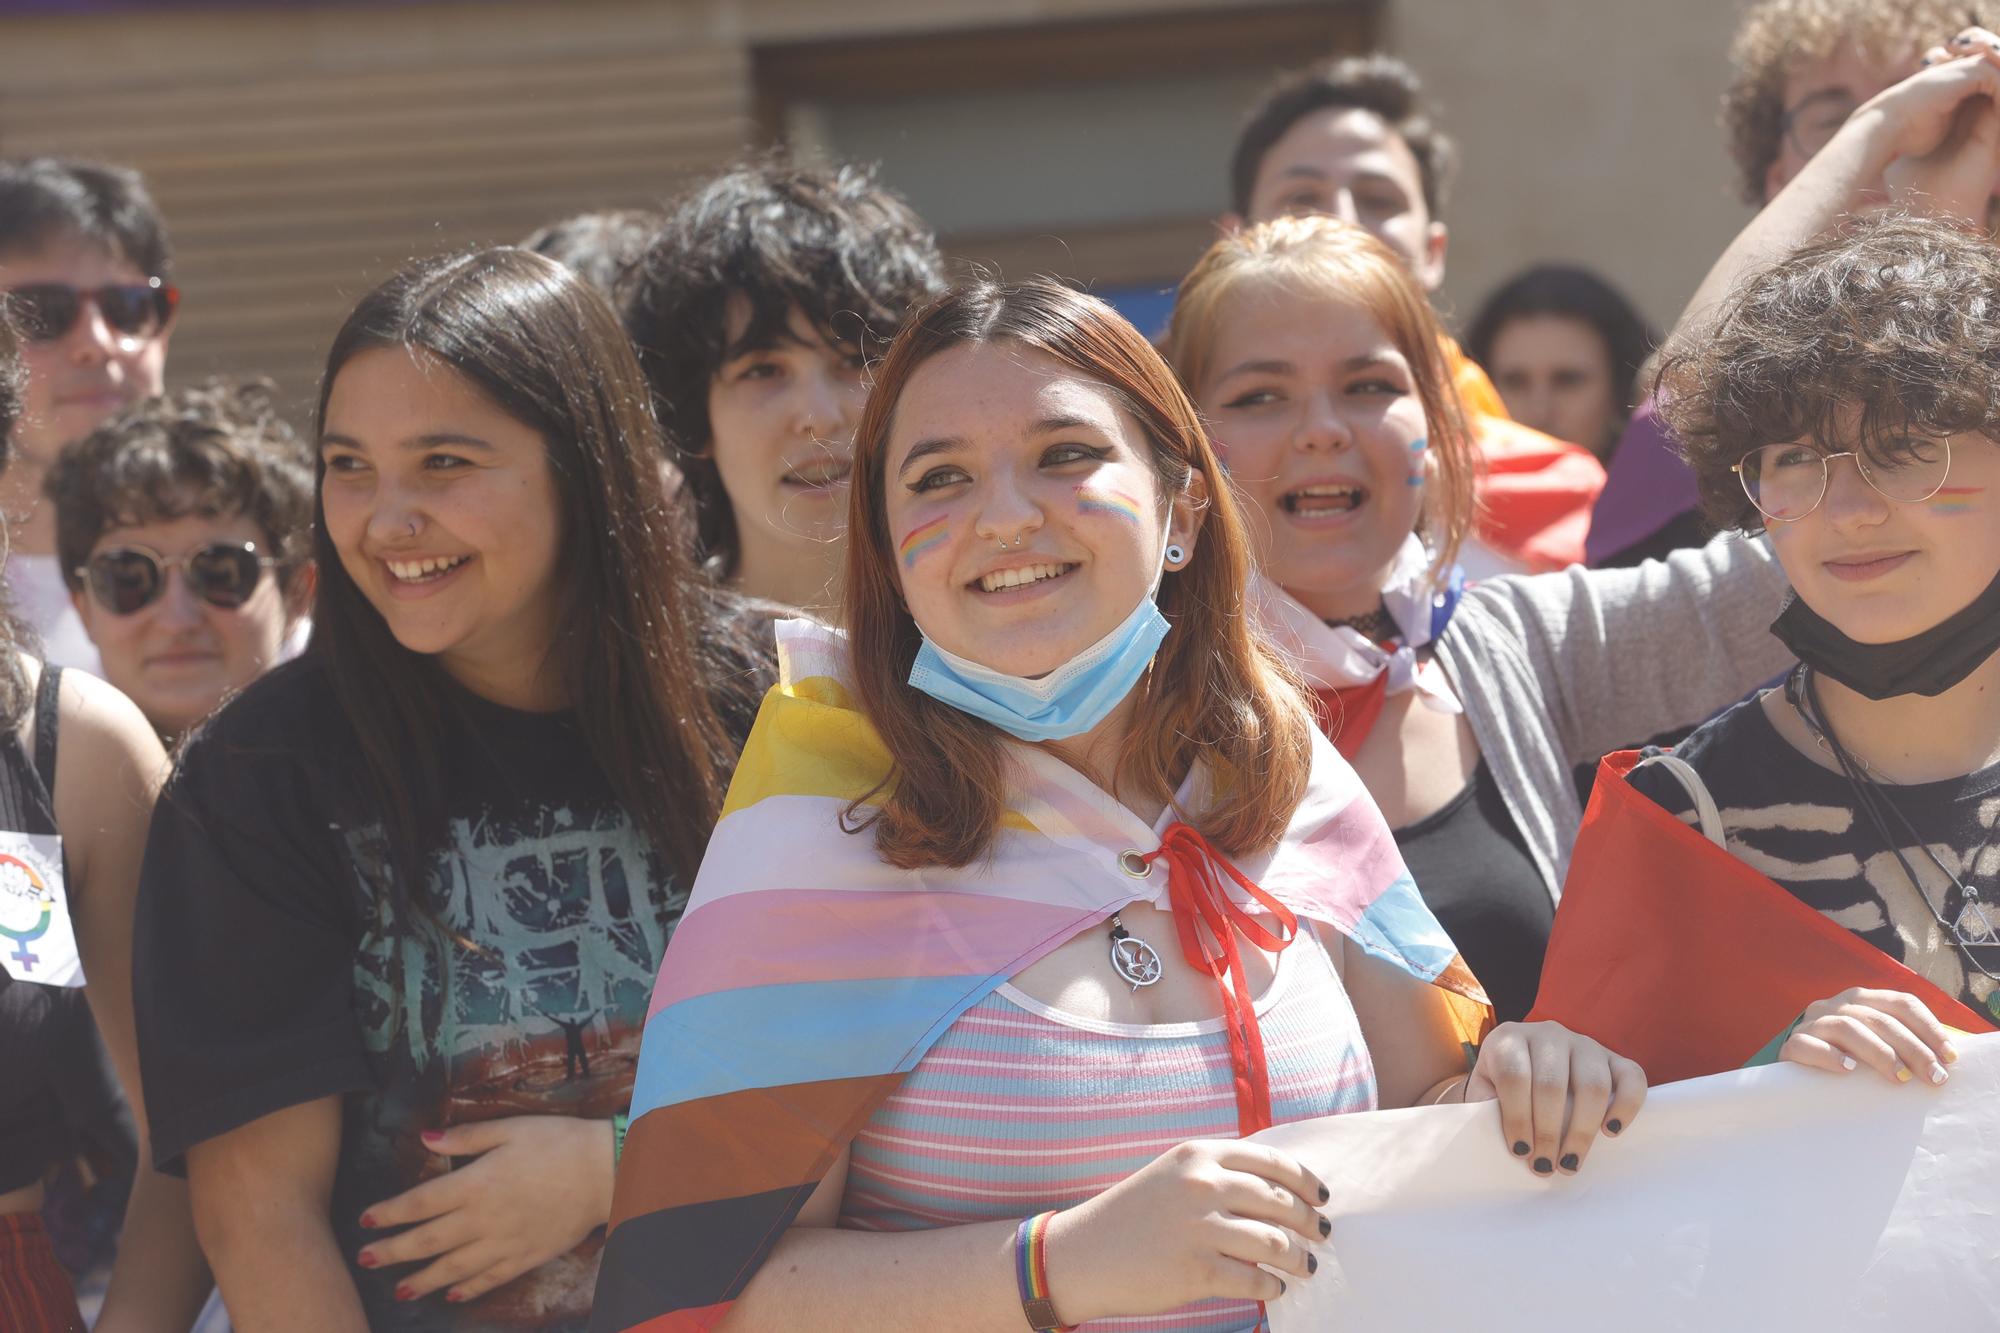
[1386,0,1750,330]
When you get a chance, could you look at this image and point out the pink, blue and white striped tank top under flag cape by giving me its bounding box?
[840,929,1376,1333]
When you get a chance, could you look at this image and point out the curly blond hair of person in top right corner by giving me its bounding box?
[1722,0,1994,206]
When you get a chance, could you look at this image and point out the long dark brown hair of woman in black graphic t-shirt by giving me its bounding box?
[310,248,748,921]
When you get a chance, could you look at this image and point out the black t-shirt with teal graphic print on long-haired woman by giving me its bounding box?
[134,656,764,1333]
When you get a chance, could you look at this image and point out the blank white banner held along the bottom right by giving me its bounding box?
[1256,1035,2000,1333]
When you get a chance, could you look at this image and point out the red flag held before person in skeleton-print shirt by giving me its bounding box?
[1528,751,1994,1083]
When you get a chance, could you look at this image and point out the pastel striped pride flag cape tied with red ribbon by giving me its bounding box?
[590,620,1488,1333]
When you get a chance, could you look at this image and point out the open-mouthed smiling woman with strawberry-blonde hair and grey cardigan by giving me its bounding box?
[1168,218,1788,1019]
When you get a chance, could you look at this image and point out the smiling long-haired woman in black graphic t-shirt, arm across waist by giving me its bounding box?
[136,250,762,1329]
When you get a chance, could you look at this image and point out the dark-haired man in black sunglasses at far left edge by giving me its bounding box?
[0,158,180,673]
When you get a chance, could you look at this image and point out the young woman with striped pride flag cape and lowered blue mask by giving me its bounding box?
[592,282,1644,1333]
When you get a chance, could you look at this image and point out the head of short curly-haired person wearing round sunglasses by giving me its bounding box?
[46,380,312,743]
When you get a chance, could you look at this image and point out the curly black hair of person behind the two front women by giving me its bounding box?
[620,160,946,578]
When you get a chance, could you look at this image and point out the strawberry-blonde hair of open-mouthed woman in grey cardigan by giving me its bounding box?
[1166,216,1480,574]
